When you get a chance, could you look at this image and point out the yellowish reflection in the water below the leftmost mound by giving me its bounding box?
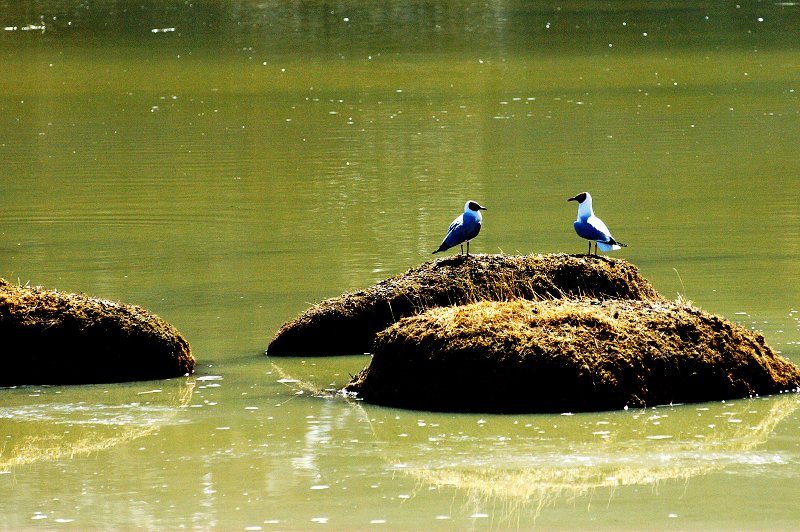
[0,378,194,472]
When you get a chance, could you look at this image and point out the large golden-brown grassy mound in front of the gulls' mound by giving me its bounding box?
[345,300,800,413]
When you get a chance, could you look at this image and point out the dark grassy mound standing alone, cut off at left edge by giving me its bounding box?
[0,279,194,386]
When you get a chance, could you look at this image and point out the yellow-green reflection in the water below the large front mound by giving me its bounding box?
[365,394,800,521]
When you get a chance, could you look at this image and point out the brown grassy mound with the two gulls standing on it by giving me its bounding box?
[267,254,662,356]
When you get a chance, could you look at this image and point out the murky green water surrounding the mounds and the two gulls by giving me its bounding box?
[0,1,800,530]
